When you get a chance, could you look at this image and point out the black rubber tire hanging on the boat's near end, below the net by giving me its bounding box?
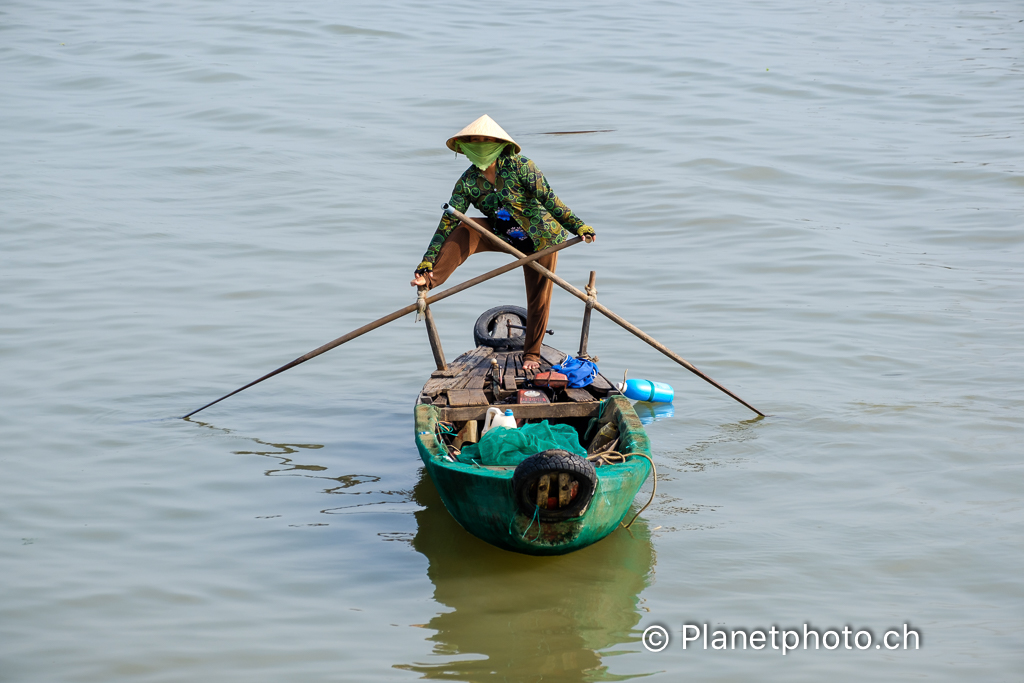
[512,449,597,522]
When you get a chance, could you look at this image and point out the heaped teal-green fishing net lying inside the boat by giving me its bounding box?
[459,420,587,467]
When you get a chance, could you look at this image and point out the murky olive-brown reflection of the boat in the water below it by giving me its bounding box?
[396,473,654,681]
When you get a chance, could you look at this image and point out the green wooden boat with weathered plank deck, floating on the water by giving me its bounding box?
[415,327,652,555]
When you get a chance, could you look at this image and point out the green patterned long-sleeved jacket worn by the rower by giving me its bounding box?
[423,148,586,263]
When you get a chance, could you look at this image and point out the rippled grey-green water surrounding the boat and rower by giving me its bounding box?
[0,1,1024,682]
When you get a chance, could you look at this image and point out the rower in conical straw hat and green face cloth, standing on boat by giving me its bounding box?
[412,114,597,370]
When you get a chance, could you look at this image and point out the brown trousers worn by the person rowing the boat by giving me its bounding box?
[427,223,558,360]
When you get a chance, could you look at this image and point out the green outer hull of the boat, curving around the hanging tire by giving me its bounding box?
[416,396,651,555]
